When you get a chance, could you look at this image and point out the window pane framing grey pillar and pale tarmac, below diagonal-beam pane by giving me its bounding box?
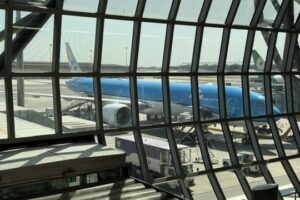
[13,77,55,138]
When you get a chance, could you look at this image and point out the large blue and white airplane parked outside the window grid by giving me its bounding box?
[66,43,280,127]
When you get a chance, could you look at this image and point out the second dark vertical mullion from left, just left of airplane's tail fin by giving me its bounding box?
[52,1,63,135]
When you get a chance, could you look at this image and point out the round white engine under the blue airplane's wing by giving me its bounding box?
[103,103,131,127]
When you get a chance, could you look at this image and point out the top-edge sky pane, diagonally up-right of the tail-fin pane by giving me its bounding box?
[106,0,138,16]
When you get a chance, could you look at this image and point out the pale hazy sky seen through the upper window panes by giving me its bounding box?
[0,0,300,67]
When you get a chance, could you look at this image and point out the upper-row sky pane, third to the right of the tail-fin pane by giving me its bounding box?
[170,25,195,72]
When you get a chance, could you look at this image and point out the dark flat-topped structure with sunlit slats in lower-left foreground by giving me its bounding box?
[0,142,181,200]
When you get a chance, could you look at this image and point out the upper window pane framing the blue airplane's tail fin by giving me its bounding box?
[60,15,96,73]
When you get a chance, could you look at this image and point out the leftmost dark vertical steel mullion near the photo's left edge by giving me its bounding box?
[4,1,16,141]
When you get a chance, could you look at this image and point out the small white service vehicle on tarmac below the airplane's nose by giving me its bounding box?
[222,152,260,174]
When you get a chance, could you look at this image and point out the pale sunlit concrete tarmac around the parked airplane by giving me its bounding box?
[0,76,300,199]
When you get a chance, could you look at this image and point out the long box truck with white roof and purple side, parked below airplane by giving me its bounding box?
[115,135,194,187]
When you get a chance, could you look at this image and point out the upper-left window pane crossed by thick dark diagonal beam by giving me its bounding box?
[12,11,54,73]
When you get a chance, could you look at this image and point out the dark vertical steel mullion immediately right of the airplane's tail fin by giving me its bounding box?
[93,0,107,145]
